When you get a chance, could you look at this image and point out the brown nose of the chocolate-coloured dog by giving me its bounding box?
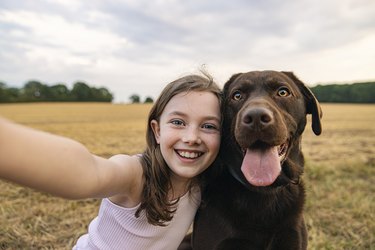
[242,108,274,130]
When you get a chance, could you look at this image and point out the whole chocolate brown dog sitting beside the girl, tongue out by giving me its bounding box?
[192,71,321,250]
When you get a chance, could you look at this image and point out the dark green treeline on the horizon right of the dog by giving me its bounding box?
[311,82,375,103]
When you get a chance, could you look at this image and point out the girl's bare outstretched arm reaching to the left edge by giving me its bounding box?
[0,117,142,199]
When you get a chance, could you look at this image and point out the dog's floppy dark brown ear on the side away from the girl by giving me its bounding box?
[282,71,323,135]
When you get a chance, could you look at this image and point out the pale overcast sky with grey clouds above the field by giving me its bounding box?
[0,0,375,102]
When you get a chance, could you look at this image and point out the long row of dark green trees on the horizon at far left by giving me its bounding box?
[0,81,113,103]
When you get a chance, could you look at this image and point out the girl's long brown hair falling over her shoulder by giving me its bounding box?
[135,72,222,226]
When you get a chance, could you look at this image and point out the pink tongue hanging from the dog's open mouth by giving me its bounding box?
[241,147,281,186]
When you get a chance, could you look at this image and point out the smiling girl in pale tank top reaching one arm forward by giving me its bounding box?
[0,75,221,250]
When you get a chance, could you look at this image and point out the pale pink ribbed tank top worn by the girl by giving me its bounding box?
[73,189,201,250]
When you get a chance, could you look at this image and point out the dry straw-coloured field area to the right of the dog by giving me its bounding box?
[303,104,375,249]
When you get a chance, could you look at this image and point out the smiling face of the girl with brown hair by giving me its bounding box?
[151,91,221,185]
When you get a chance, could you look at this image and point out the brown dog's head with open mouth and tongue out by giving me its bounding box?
[220,71,322,189]
